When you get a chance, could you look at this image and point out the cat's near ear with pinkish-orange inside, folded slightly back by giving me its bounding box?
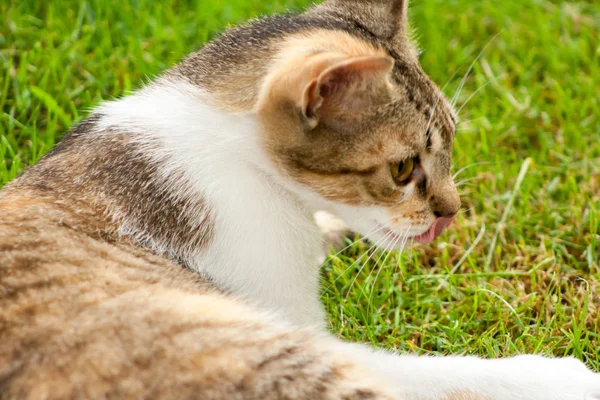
[301,56,394,129]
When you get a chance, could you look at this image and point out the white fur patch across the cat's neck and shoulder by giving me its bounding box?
[91,81,324,325]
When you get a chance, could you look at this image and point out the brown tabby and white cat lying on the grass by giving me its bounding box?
[0,0,600,400]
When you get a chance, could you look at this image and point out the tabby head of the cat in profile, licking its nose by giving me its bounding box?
[257,0,460,247]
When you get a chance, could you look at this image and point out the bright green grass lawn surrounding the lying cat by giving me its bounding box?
[0,0,600,370]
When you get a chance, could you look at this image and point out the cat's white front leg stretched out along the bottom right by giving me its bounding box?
[338,344,600,400]
